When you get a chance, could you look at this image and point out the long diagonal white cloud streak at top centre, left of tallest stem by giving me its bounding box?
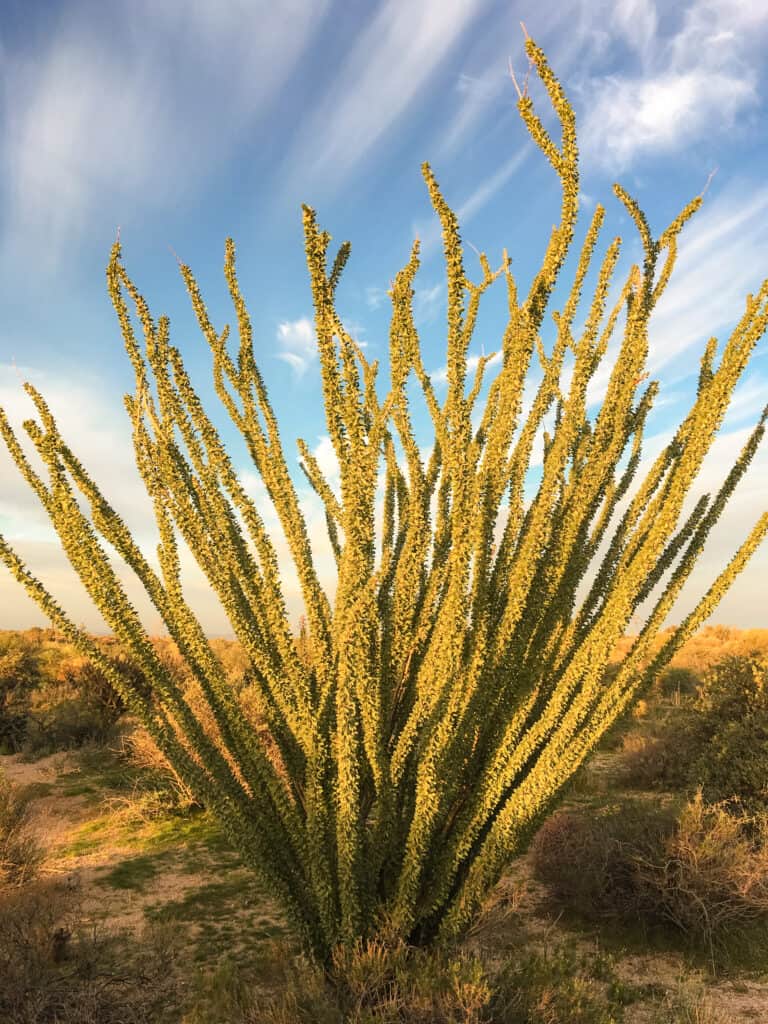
[286,0,487,197]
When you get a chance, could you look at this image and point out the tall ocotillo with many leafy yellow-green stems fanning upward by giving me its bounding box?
[0,40,768,958]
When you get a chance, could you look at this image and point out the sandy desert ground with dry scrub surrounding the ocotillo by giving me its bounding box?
[0,627,768,1024]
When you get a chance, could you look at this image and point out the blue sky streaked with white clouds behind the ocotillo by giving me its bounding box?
[0,0,768,635]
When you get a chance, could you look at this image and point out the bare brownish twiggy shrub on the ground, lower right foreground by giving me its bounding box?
[530,791,768,967]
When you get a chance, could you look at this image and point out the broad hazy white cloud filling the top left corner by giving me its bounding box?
[0,0,330,272]
